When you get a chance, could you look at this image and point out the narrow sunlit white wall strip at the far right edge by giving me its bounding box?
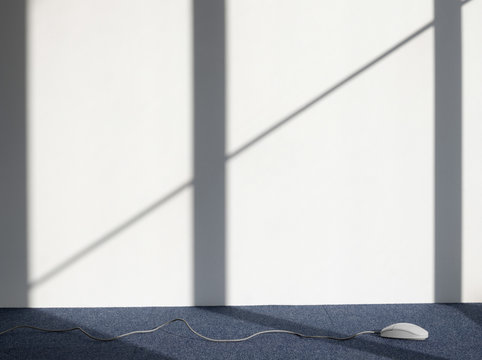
[462,0,482,302]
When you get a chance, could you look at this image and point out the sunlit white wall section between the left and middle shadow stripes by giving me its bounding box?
[28,0,192,306]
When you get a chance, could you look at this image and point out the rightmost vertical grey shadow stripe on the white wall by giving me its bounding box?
[434,0,462,302]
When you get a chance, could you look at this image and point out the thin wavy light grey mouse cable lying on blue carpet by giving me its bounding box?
[0,318,379,343]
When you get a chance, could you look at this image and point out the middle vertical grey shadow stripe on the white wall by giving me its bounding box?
[192,0,226,305]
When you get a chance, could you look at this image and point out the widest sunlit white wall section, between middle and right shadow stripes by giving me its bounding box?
[228,1,434,304]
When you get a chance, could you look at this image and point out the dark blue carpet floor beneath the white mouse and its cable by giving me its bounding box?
[0,304,482,360]
